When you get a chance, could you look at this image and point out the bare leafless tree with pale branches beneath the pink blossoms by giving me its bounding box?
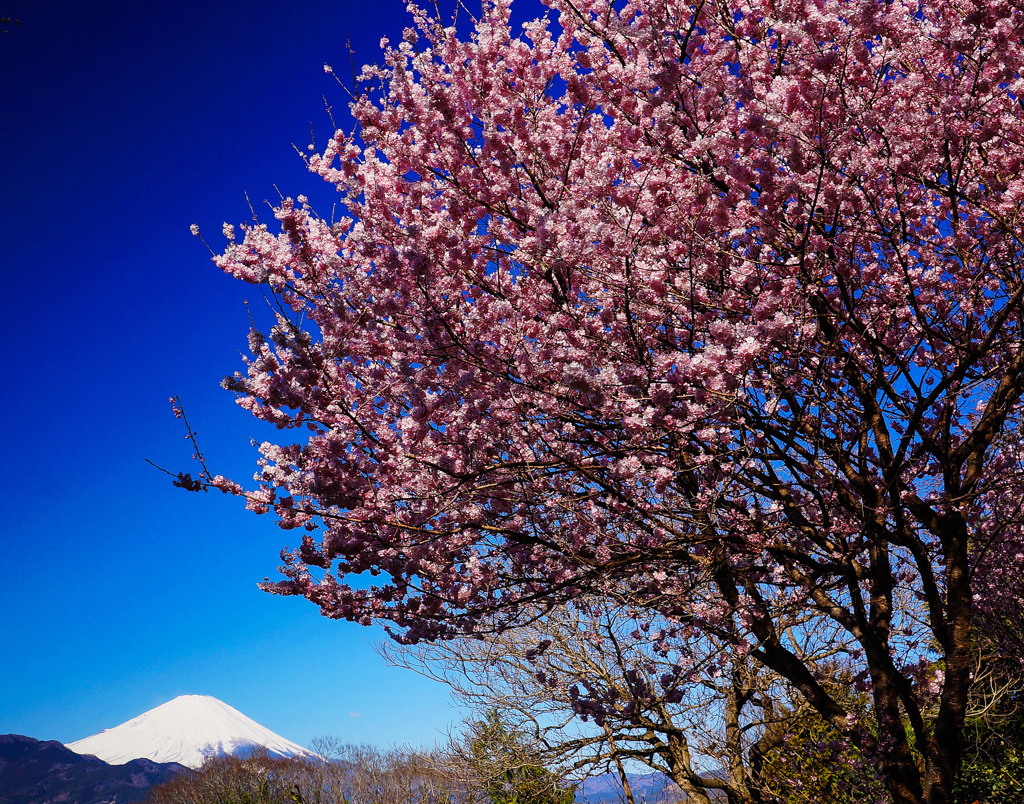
[378,599,871,804]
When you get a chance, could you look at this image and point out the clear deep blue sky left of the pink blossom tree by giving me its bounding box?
[0,0,540,746]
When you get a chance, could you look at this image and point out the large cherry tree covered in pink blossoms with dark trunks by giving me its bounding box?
[188,0,1024,804]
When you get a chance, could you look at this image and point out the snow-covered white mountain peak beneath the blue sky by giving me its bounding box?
[68,695,313,768]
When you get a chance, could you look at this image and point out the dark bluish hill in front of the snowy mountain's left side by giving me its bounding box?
[0,734,185,804]
